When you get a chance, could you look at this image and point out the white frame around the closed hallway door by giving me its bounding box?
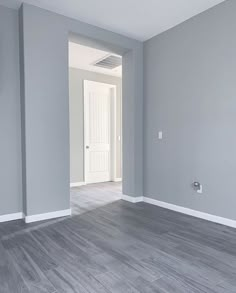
[83,79,117,184]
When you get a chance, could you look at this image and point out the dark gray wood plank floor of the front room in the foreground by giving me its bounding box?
[0,181,236,293]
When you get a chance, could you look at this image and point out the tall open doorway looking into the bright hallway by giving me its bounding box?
[69,43,122,214]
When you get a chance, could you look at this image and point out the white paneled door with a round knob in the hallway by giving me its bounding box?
[84,80,115,183]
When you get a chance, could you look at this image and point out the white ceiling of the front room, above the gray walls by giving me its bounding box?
[0,0,224,41]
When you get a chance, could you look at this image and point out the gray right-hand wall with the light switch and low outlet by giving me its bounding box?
[144,0,236,220]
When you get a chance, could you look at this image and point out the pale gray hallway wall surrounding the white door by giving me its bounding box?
[69,68,122,183]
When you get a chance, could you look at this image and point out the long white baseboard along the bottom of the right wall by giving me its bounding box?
[143,197,236,228]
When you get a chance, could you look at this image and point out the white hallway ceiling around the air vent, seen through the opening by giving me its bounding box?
[69,42,122,77]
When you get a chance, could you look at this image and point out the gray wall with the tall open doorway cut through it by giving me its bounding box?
[21,4,143,215]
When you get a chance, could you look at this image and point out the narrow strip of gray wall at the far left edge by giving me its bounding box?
[0,6,22,215]
